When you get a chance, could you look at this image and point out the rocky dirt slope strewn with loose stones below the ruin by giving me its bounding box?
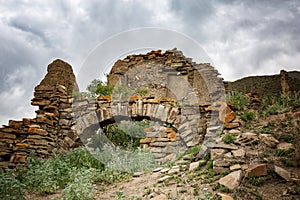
[26,110,300,200]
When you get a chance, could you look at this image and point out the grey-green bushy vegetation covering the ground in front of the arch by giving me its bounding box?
[0,145,156,200]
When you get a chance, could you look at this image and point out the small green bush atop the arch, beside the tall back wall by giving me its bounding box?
[86,79,113,97]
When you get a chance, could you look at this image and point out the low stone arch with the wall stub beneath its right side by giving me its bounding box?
[73,96,225,162]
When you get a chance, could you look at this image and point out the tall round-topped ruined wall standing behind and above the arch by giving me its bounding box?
[108,49,223,103]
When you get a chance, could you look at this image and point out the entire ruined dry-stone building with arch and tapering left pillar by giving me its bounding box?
[0,49,230,168]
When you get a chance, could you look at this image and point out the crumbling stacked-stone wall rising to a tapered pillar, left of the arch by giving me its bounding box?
[0,60,80,168]
